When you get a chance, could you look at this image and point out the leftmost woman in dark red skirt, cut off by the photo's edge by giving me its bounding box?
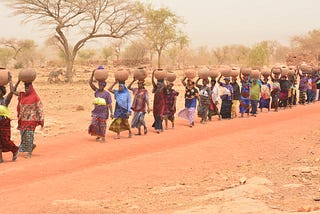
[0,73,19,163]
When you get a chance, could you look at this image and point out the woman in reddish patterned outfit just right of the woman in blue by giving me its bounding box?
[128,78,150,135]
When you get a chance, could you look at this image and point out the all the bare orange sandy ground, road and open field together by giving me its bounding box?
[0,69,320,214]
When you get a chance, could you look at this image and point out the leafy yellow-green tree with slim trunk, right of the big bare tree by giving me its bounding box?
[144,6,187,68]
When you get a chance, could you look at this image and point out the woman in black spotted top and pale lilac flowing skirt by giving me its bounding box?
[178,77,200,128]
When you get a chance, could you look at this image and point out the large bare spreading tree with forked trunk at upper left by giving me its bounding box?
[3,0,143,81]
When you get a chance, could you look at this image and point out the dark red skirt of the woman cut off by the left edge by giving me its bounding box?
[0,118,19,153]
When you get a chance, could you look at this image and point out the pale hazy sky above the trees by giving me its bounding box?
[0,0,320,47]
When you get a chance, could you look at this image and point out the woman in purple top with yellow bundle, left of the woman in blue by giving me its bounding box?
[88,70,113,142]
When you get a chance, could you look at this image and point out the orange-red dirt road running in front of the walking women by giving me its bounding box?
[0,102,320,214]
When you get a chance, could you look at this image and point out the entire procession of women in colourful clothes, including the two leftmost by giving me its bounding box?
[0,65,320,163]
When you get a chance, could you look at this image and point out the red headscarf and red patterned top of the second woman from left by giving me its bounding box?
[17,85,44,130]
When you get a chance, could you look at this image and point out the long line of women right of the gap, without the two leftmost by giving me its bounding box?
[89,66,320,142]
